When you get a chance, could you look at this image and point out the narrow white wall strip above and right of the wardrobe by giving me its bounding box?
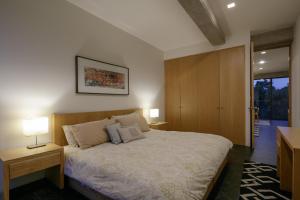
[164,31,251,146]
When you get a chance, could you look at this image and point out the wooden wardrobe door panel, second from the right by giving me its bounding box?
[197,52,220,134]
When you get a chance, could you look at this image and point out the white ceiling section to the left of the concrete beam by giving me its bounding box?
[68,0,207,51]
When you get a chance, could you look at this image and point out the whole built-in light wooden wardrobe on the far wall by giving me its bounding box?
[165,46,245,145]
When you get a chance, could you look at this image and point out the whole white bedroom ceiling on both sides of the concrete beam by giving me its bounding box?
[67,0,300,51]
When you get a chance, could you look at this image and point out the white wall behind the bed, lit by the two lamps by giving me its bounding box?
[0,0,164,190]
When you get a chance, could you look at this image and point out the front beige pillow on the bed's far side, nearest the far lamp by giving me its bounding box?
[113,112,150,132]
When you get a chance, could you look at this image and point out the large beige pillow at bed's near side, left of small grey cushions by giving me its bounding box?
[71,119,114,149]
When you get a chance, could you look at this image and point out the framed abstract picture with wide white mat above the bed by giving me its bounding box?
[76,56,129,95]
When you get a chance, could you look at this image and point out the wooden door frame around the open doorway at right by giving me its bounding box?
[249,41,292,149]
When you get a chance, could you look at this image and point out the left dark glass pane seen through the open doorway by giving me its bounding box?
[254,79,271,120]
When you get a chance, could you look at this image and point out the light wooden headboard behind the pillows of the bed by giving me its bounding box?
[52,108,142,146]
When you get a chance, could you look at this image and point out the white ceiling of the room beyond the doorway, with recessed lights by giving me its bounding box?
[253,47,289,74]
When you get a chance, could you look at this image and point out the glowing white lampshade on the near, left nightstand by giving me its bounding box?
[23,117,48,136]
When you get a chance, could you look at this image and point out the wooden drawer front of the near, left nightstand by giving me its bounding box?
[9,152,61,178]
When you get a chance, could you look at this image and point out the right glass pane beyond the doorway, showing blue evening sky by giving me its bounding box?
[272,78,289,120]
